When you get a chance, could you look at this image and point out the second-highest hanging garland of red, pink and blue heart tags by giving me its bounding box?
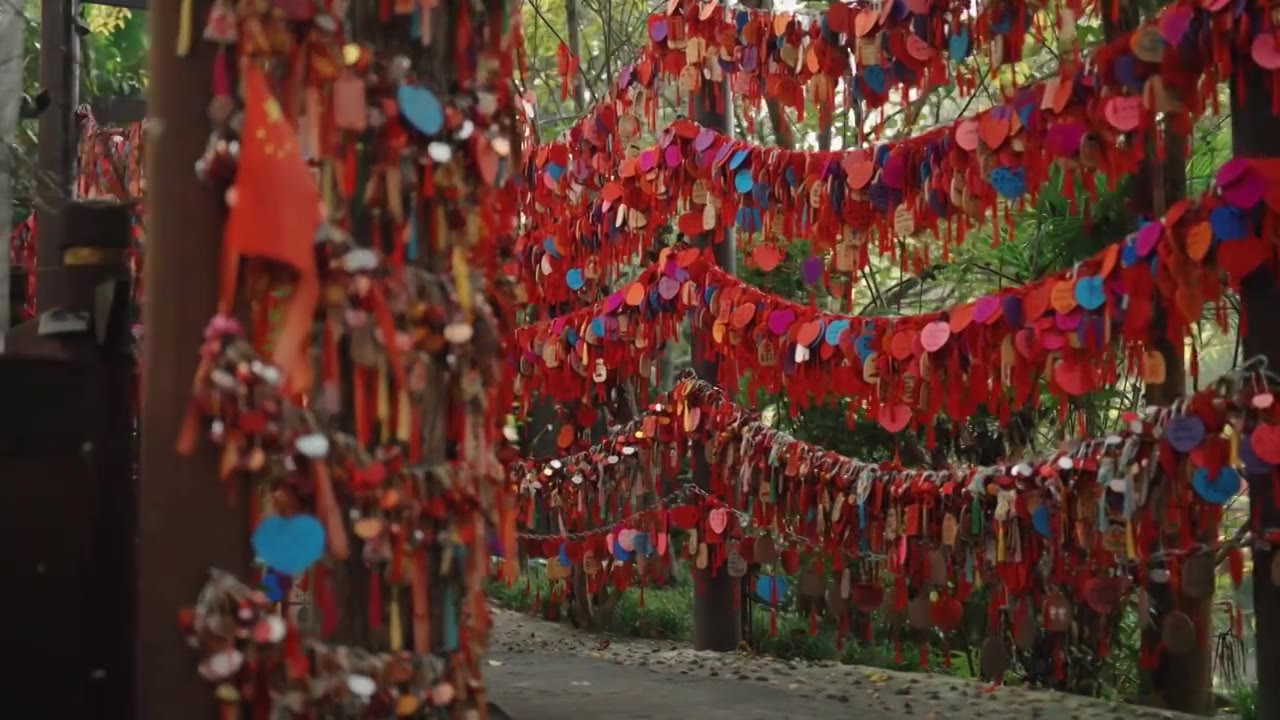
[518,1,1280,304]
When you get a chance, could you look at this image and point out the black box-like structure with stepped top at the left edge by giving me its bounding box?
[0,202,137,720]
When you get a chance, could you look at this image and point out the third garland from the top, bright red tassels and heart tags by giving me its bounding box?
[516,160,1280,439]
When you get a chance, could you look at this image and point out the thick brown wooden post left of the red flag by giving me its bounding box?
[140,0,250,720]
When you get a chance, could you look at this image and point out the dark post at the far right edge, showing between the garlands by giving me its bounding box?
[1231,47,1280,720]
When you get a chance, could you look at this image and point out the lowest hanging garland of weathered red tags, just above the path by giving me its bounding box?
[513,363,1280,680]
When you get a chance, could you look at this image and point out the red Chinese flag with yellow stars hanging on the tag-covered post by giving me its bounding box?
[219,63,320,392]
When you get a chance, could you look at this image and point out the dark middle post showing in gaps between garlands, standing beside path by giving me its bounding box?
[691,81,742,652]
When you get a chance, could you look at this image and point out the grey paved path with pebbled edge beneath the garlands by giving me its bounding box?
[485,610,1208,720]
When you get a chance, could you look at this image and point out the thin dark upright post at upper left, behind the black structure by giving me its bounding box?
[36,0,79,313]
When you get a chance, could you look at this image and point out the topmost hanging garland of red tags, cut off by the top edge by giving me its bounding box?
[540,0,1094,147]
